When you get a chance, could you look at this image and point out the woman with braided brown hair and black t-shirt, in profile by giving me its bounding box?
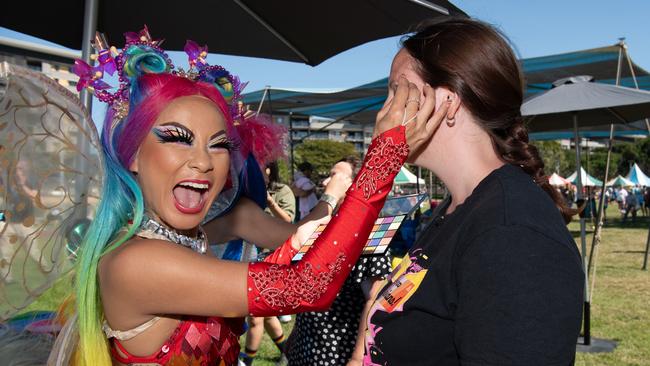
[351,19,584,365]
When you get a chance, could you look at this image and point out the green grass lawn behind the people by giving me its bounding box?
[15,206,650,366]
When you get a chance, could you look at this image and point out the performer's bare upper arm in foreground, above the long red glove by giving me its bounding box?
[99,238,247,319]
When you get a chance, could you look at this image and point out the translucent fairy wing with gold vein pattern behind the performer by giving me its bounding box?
[0,63,103,320]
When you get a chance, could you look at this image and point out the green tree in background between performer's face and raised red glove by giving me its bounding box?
[294,140,359,178]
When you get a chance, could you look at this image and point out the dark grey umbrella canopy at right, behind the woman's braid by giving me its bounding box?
[521,76,650,132]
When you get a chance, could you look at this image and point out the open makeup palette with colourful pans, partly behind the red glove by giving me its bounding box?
[291,215,406,261]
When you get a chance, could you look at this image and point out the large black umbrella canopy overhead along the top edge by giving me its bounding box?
[0,0,465,66]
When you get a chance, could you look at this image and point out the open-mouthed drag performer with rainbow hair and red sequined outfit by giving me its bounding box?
[33,28,449,366]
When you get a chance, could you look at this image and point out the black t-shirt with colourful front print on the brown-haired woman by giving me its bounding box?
[365,164,584,366]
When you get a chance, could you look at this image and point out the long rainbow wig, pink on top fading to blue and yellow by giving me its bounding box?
[74,73,241,366]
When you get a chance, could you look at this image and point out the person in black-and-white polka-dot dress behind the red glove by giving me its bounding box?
[287,156,390,366]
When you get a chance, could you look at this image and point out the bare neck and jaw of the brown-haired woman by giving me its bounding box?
[418,117,505,214]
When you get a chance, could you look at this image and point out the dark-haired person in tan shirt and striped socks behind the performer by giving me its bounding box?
[239,162,296,366]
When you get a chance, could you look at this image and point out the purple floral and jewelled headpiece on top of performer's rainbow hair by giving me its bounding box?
[72,25,247,121]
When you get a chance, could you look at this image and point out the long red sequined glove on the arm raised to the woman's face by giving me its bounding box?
[248,126,409,316]
